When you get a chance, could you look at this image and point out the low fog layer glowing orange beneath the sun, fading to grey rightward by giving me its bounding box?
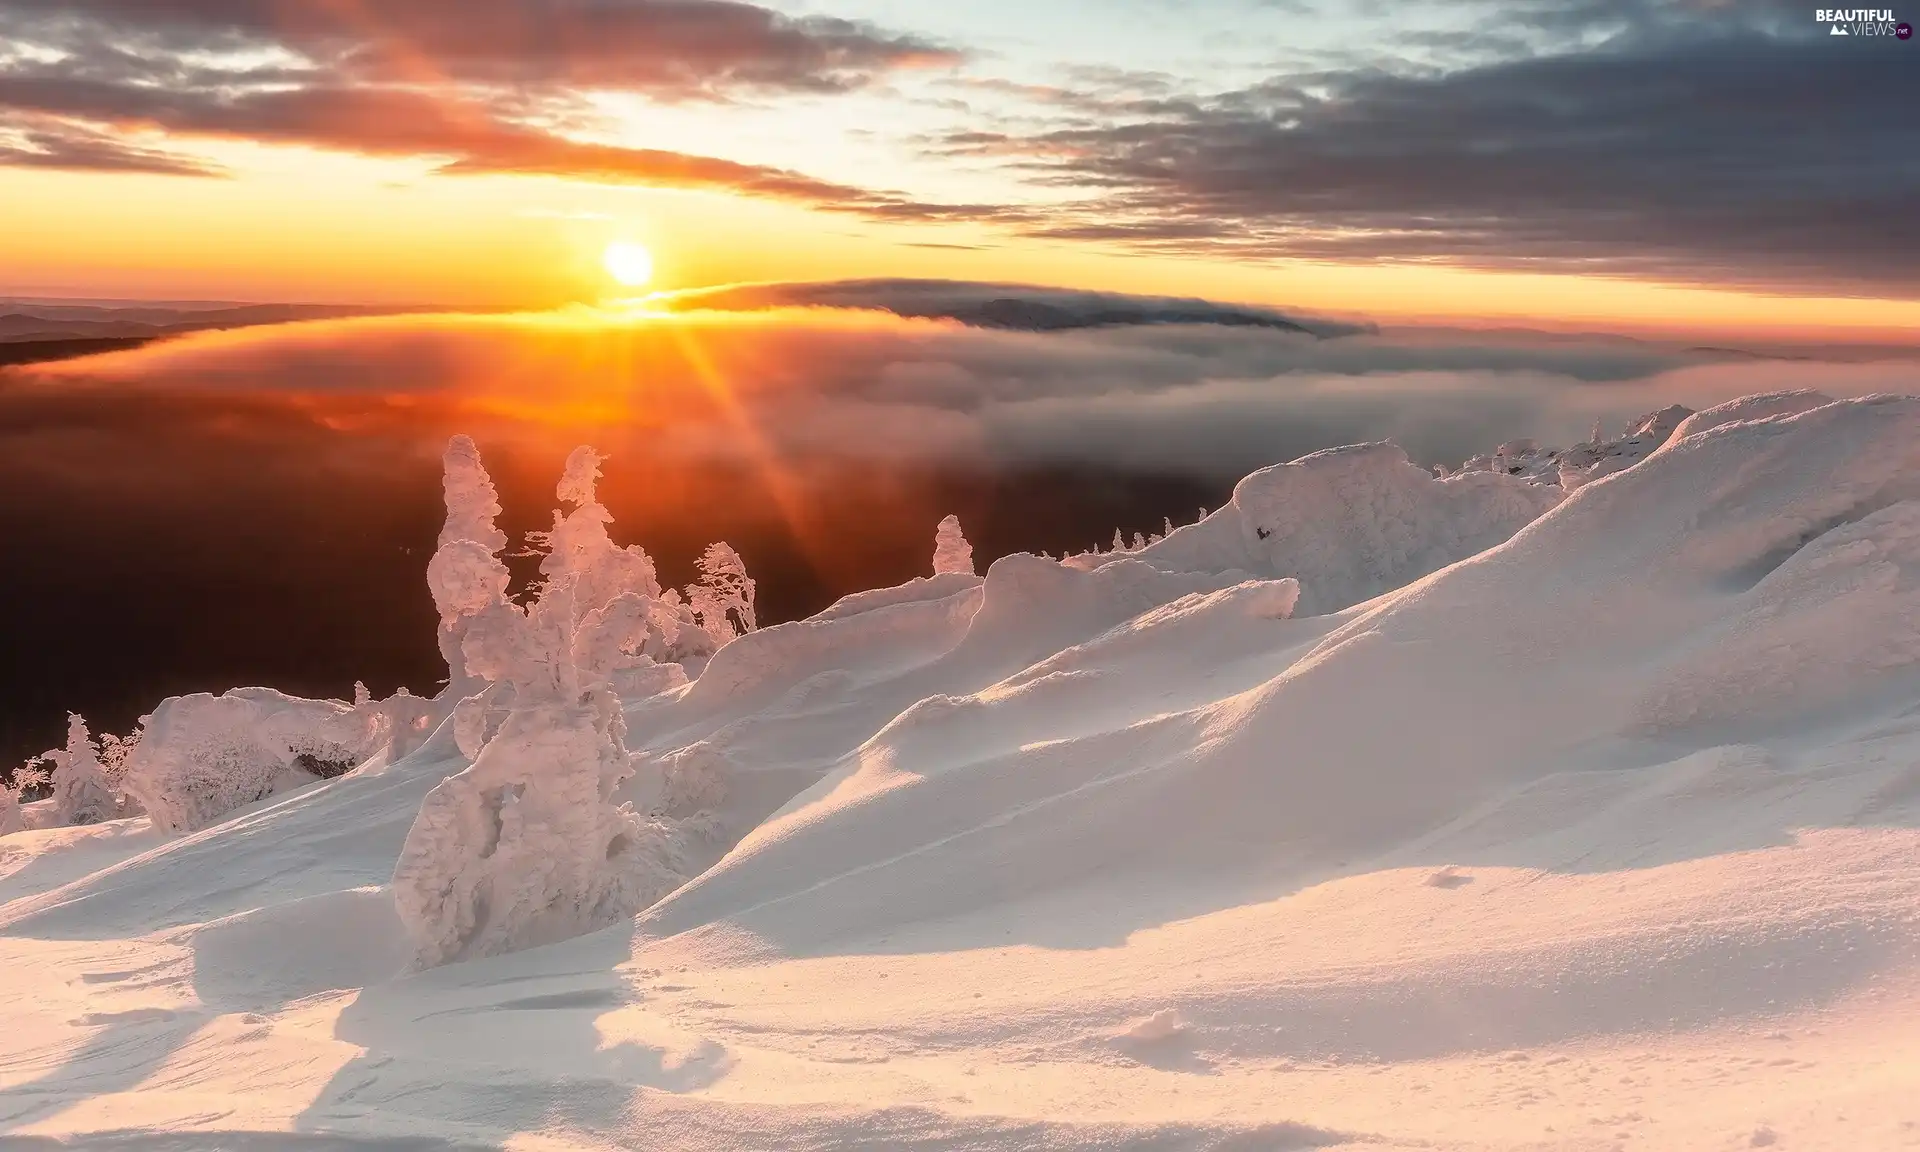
[18,297,1914,478]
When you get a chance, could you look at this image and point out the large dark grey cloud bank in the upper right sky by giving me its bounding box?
[948,18,1920,296]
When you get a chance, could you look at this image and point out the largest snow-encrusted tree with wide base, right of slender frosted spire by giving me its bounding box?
[392,447,725,966]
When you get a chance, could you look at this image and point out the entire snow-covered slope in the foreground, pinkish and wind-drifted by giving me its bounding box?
[0,397,1920,1150]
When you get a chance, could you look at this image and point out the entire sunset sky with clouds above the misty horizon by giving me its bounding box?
[0,0,1920,342]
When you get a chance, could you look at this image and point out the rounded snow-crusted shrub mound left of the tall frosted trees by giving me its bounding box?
[127,687,390,833]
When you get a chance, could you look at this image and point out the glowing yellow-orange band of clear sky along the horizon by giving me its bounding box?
[0,119,1920,344]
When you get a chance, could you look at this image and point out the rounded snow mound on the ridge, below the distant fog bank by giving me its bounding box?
[1129,444,1561,614]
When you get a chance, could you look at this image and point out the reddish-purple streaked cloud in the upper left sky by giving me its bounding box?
[0,0,952,204]
